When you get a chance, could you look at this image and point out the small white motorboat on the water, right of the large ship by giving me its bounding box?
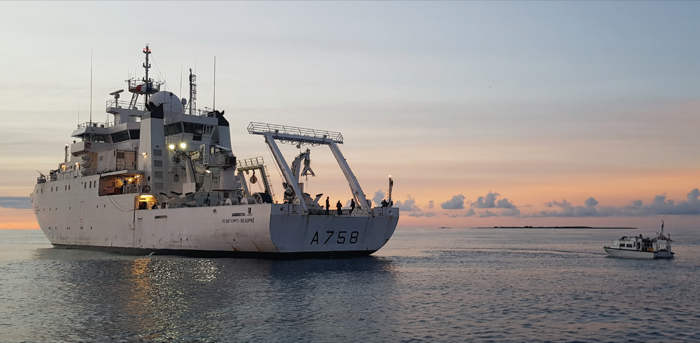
[603,220,674,259]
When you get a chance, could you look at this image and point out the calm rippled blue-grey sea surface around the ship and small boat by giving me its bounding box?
[0,227,700,342]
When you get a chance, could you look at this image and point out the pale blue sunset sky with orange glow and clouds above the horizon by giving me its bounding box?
[0,1,700,228]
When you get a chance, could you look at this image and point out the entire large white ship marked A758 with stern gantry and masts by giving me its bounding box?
[31,46,399,256]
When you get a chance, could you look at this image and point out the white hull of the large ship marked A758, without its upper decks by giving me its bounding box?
[33,189,399,258]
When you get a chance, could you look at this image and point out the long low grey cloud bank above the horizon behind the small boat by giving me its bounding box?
[525,188,700,217]
